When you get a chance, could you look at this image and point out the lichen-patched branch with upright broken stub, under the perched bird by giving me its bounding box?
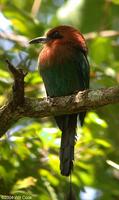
[0,61,119,137]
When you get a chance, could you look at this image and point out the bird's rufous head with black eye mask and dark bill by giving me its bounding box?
[29,25,87,52]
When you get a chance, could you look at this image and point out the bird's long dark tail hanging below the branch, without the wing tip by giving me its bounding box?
[56,114,77,176]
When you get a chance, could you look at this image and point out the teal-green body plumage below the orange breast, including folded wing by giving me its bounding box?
[39,49,89,97]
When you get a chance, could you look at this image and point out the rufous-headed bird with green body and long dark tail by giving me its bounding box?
[29,25,89,176]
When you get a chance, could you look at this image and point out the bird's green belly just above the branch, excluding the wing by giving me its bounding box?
[40,66,80,97]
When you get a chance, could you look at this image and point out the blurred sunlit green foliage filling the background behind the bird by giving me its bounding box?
[0,0,119,200]
